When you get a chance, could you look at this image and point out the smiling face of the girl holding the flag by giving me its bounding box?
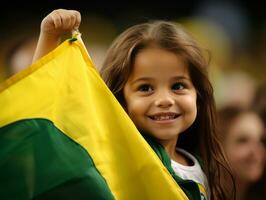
[123,48,197,144]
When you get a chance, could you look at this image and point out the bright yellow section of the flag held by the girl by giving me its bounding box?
[0,36,188,200]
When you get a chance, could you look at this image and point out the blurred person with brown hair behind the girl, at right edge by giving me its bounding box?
[219,106,265,200]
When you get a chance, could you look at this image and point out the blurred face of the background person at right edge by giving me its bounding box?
[225,113,265,183]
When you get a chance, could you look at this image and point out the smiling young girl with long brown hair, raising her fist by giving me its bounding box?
[33,9,234,199]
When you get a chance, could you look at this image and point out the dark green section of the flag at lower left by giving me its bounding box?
[0,119,114,200]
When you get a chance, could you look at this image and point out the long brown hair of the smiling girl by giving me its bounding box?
[100,21,235,199]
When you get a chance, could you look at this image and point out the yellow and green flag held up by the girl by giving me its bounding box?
[0,35,191,200]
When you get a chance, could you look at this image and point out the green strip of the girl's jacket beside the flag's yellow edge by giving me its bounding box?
[144,135,201,200]
